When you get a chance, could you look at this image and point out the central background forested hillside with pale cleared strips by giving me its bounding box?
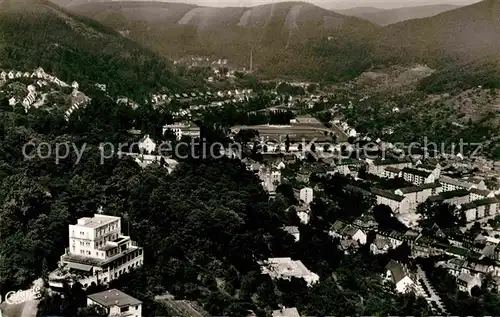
[68,1,377,80]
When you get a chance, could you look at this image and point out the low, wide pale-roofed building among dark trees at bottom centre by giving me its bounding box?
[259,258,319,286]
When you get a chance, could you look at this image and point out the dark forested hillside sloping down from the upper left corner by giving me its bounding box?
[0,0,192,96]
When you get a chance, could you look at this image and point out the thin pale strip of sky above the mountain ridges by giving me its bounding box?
[125,0,479,10]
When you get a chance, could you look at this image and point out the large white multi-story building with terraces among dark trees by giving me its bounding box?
[49,214,144,288]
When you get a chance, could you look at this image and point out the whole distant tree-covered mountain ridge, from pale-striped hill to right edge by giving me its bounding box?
[68,0,500,86]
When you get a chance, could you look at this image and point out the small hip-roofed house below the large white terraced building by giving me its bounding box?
[87,288,142,317]
